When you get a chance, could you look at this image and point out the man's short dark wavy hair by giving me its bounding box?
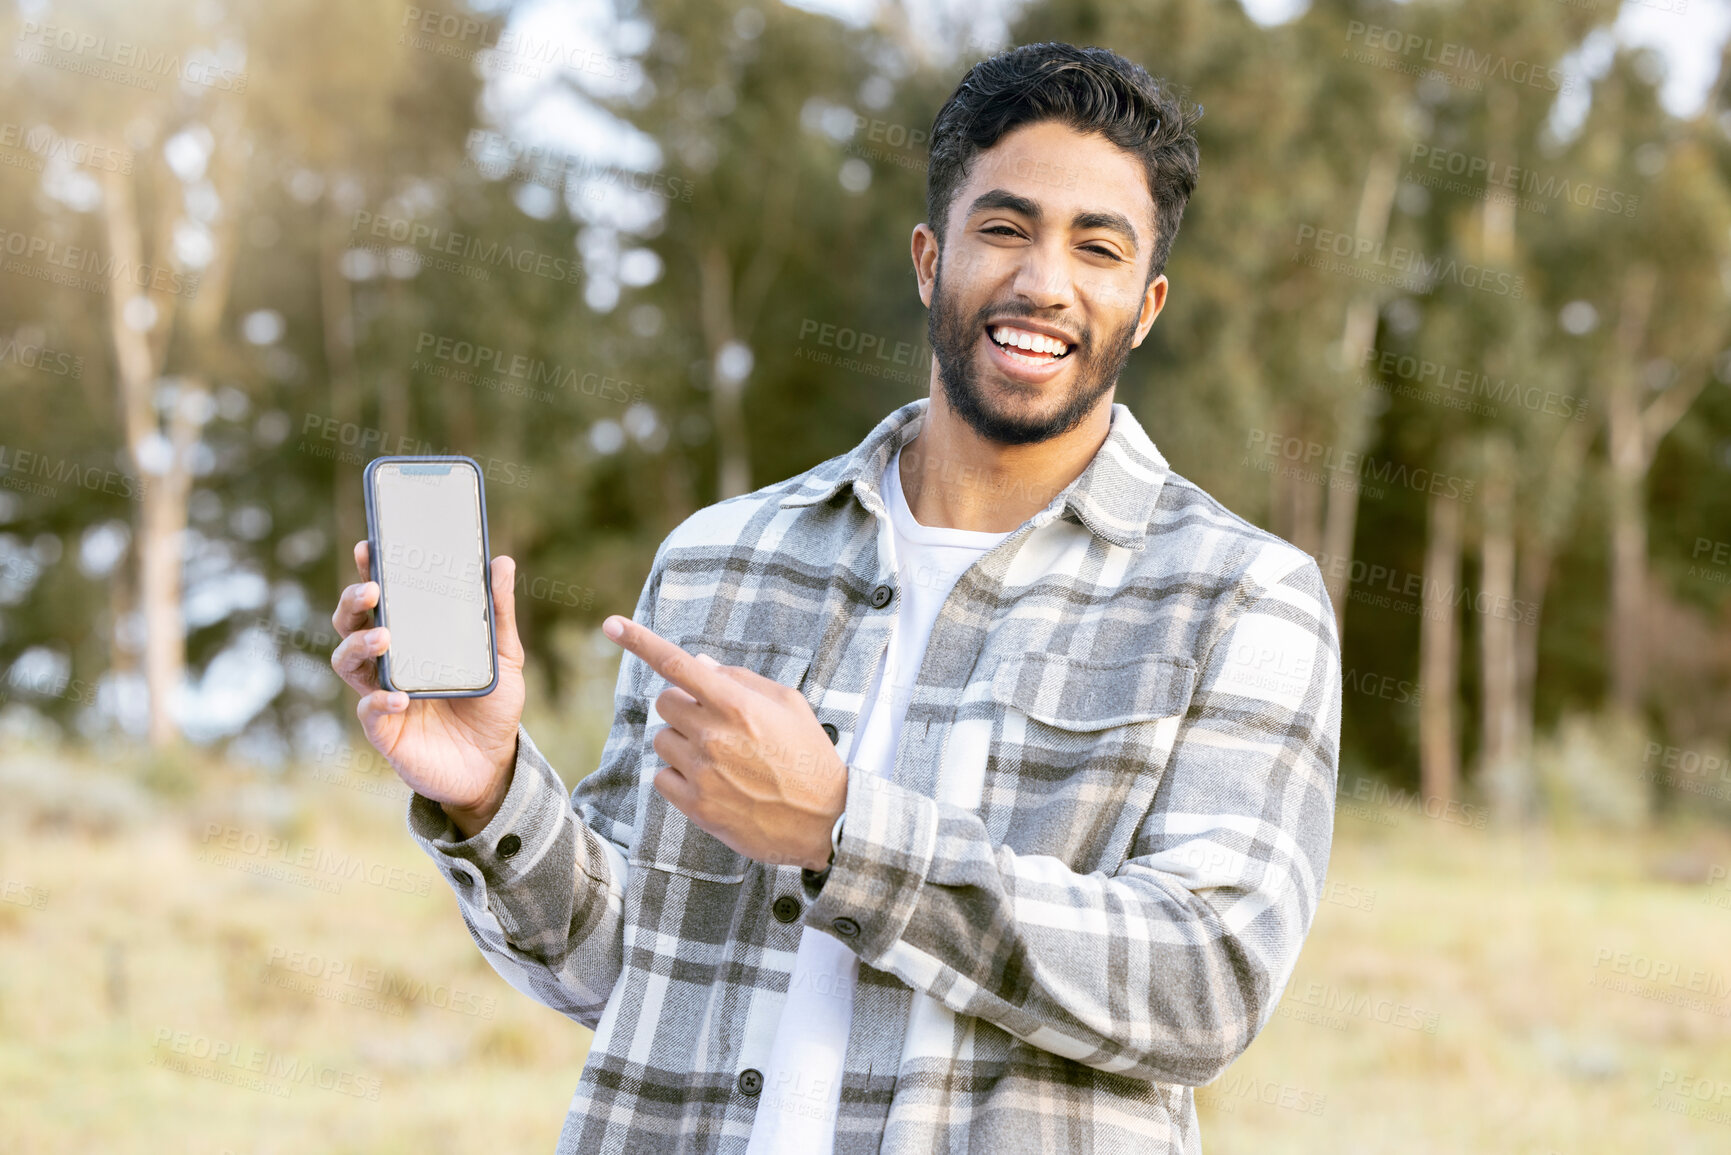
[926,43,1201,281]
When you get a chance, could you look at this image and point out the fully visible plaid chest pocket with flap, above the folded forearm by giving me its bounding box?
[981,653,1196,871]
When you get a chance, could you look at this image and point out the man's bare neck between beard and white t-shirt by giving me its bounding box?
[898,384,1111,533]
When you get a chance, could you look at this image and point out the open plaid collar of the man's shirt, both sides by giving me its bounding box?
[781,397,1172,549]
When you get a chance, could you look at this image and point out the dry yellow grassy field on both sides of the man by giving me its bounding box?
[0,730,1731,1155]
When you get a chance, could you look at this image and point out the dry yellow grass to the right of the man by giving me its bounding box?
[1198,814,1731,1155]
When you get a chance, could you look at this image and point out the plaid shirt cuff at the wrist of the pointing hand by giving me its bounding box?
[803,767,938,963]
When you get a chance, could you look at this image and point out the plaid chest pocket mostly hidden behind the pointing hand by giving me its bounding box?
[627,634,812,883]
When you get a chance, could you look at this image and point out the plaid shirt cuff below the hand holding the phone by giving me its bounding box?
[409,724,571,935]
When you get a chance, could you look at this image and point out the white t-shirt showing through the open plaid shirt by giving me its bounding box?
[746,450,1011,1155]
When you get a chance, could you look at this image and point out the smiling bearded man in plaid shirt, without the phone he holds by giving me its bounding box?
[332,45,1340,1155]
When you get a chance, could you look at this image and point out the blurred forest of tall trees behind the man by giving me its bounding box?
[0,0,1731,1150]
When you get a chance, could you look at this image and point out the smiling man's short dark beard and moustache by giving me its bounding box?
[926,258,1136,445]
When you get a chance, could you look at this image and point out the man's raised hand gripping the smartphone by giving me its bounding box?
[331,542,524,838]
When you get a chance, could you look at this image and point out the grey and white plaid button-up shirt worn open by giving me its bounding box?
[409,400,1342,1155]
